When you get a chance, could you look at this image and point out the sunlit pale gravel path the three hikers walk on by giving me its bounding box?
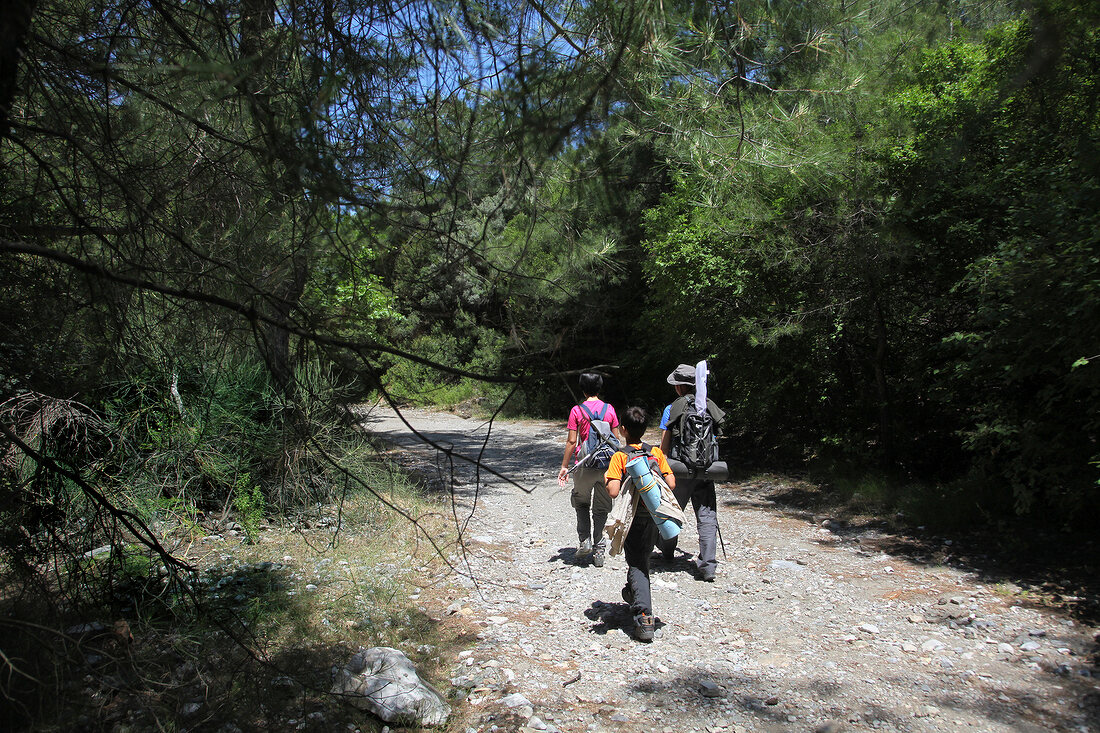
[363,408,1100,733]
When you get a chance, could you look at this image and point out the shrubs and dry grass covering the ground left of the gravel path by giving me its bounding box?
[0,368,468,731]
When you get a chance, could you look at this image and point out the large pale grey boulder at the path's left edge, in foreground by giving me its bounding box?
[332,646,451,726]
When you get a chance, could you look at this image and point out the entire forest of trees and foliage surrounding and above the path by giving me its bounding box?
[0,0,1100,581]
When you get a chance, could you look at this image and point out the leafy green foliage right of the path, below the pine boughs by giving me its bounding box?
[629,0,1100,521]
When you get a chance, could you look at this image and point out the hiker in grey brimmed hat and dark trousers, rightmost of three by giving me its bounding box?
[660,362,726,582]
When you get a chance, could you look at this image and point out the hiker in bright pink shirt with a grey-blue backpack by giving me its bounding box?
[558,373,619,568]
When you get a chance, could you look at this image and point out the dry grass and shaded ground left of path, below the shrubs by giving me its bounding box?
[0,471,462,733]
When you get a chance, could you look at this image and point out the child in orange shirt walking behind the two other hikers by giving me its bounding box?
[605,406,677,642]
